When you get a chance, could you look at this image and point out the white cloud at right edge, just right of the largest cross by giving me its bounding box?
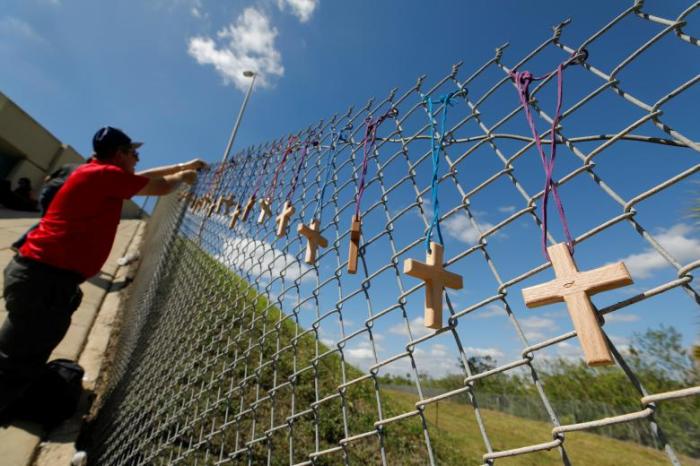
[622,223,700,279]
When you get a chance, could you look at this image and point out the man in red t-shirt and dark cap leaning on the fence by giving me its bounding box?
[0,126,206,413]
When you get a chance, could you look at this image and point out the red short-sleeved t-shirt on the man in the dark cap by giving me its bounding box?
[19,160,148,279]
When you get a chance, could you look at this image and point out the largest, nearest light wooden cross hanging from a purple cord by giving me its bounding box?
[523,243,633,366]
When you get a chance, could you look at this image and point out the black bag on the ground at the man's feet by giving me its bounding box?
[11,359,85,428]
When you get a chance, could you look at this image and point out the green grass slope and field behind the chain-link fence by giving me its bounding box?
[100,240,700,466]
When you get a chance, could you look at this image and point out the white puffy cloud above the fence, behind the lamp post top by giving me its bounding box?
[187,7,284,90]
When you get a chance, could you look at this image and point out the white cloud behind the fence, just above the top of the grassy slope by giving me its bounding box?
[216,238,315,281]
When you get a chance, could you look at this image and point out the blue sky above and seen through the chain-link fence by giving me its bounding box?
[0,0,700,375]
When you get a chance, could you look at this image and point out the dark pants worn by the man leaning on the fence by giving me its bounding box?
[0,256,83,413]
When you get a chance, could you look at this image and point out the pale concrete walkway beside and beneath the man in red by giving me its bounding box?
[0,208,144,466]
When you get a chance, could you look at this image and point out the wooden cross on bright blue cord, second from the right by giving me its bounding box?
[403,241,462,329]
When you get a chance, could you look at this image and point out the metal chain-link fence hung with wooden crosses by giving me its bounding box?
[89,1,700,465]
